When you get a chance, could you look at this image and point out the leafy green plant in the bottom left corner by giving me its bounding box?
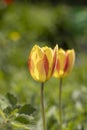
[0,93,36,130]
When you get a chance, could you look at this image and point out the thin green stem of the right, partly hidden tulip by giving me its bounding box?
[59,78,62,130]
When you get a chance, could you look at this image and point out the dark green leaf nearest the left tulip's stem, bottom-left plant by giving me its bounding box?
[18,104,36,115]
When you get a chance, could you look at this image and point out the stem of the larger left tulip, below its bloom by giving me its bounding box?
[41,83,47,130]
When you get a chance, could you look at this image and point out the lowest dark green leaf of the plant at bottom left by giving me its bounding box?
[15,115,30,124]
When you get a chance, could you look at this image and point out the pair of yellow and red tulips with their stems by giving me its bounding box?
[28,45,75,130]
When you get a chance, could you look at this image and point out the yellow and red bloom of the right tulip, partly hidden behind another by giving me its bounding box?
[53,49,75,78]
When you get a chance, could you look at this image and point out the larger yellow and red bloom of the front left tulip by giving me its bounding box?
[28,45,58,82]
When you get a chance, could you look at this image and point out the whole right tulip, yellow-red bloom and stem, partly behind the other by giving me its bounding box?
[53,49,75,130]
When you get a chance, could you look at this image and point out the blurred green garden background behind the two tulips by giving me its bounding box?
[0,0,87,130]
